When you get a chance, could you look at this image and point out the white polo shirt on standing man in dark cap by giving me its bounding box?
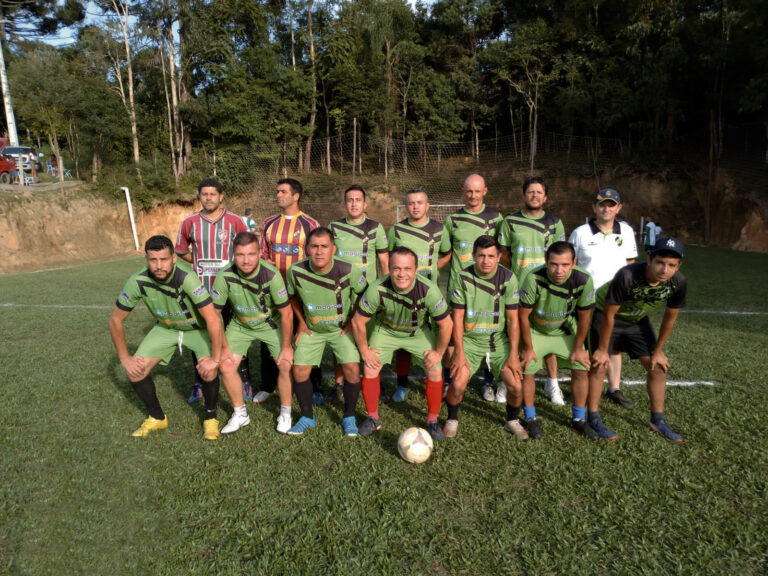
[568,219,637,288]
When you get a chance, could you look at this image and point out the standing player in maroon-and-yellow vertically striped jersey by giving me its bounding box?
[253,178,323,404]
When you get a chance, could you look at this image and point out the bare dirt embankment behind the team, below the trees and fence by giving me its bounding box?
[0,177,768,273]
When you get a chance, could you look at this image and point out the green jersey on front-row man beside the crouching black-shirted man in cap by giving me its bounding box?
[520,266,595,334]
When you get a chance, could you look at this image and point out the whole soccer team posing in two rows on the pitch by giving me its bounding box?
[110,174,686,442]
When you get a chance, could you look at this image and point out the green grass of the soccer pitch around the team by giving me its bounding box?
[0,247,768,575]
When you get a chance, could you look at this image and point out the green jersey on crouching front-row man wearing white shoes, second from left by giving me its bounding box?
[211,260,289,329]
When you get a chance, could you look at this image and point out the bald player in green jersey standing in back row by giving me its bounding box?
[443,174,507,403]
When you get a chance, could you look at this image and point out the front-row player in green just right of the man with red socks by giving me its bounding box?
[443,236,528,440]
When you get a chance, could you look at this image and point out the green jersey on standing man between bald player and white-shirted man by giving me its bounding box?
[499,210,565,280]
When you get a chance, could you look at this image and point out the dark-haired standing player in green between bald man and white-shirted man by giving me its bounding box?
[499,176,565,406]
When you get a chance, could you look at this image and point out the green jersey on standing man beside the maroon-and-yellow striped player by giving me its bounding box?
[328,218,389,282]
